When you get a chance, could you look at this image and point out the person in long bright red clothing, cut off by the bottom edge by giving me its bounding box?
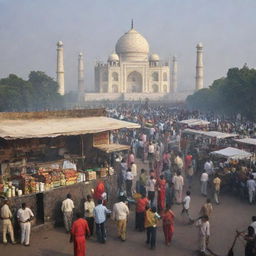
[70,213,90,256]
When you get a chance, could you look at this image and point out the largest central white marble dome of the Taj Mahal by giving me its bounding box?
[116,29,149,61]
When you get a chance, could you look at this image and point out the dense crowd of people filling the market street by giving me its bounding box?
[1,103,256,256]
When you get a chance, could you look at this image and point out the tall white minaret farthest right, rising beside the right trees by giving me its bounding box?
[195,43,204,91]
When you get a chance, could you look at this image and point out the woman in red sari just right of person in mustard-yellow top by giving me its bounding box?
[163,206,174,246]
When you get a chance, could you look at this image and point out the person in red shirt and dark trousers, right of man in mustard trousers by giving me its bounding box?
[135,194,149,231]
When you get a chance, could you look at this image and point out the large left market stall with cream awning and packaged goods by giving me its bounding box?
[0,110,140,225]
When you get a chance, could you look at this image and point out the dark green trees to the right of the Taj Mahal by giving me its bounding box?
[186,65,256,121]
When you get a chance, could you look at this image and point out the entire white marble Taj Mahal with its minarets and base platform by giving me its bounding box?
[57,22,203,101]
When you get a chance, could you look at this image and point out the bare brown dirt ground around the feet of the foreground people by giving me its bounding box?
[0,159,256,256]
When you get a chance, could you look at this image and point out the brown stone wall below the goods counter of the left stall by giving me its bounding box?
[4,175,118,226]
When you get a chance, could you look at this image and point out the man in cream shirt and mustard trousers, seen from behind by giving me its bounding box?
[112,196,129,241]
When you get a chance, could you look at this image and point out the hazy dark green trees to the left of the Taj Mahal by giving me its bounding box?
[0,71,63,111]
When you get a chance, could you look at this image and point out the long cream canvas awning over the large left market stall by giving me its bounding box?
[0,116,140,140]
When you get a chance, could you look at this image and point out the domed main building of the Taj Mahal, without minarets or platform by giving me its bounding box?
[95,22,171,93]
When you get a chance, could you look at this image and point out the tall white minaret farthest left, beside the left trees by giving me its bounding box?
[56,41,65,95]
